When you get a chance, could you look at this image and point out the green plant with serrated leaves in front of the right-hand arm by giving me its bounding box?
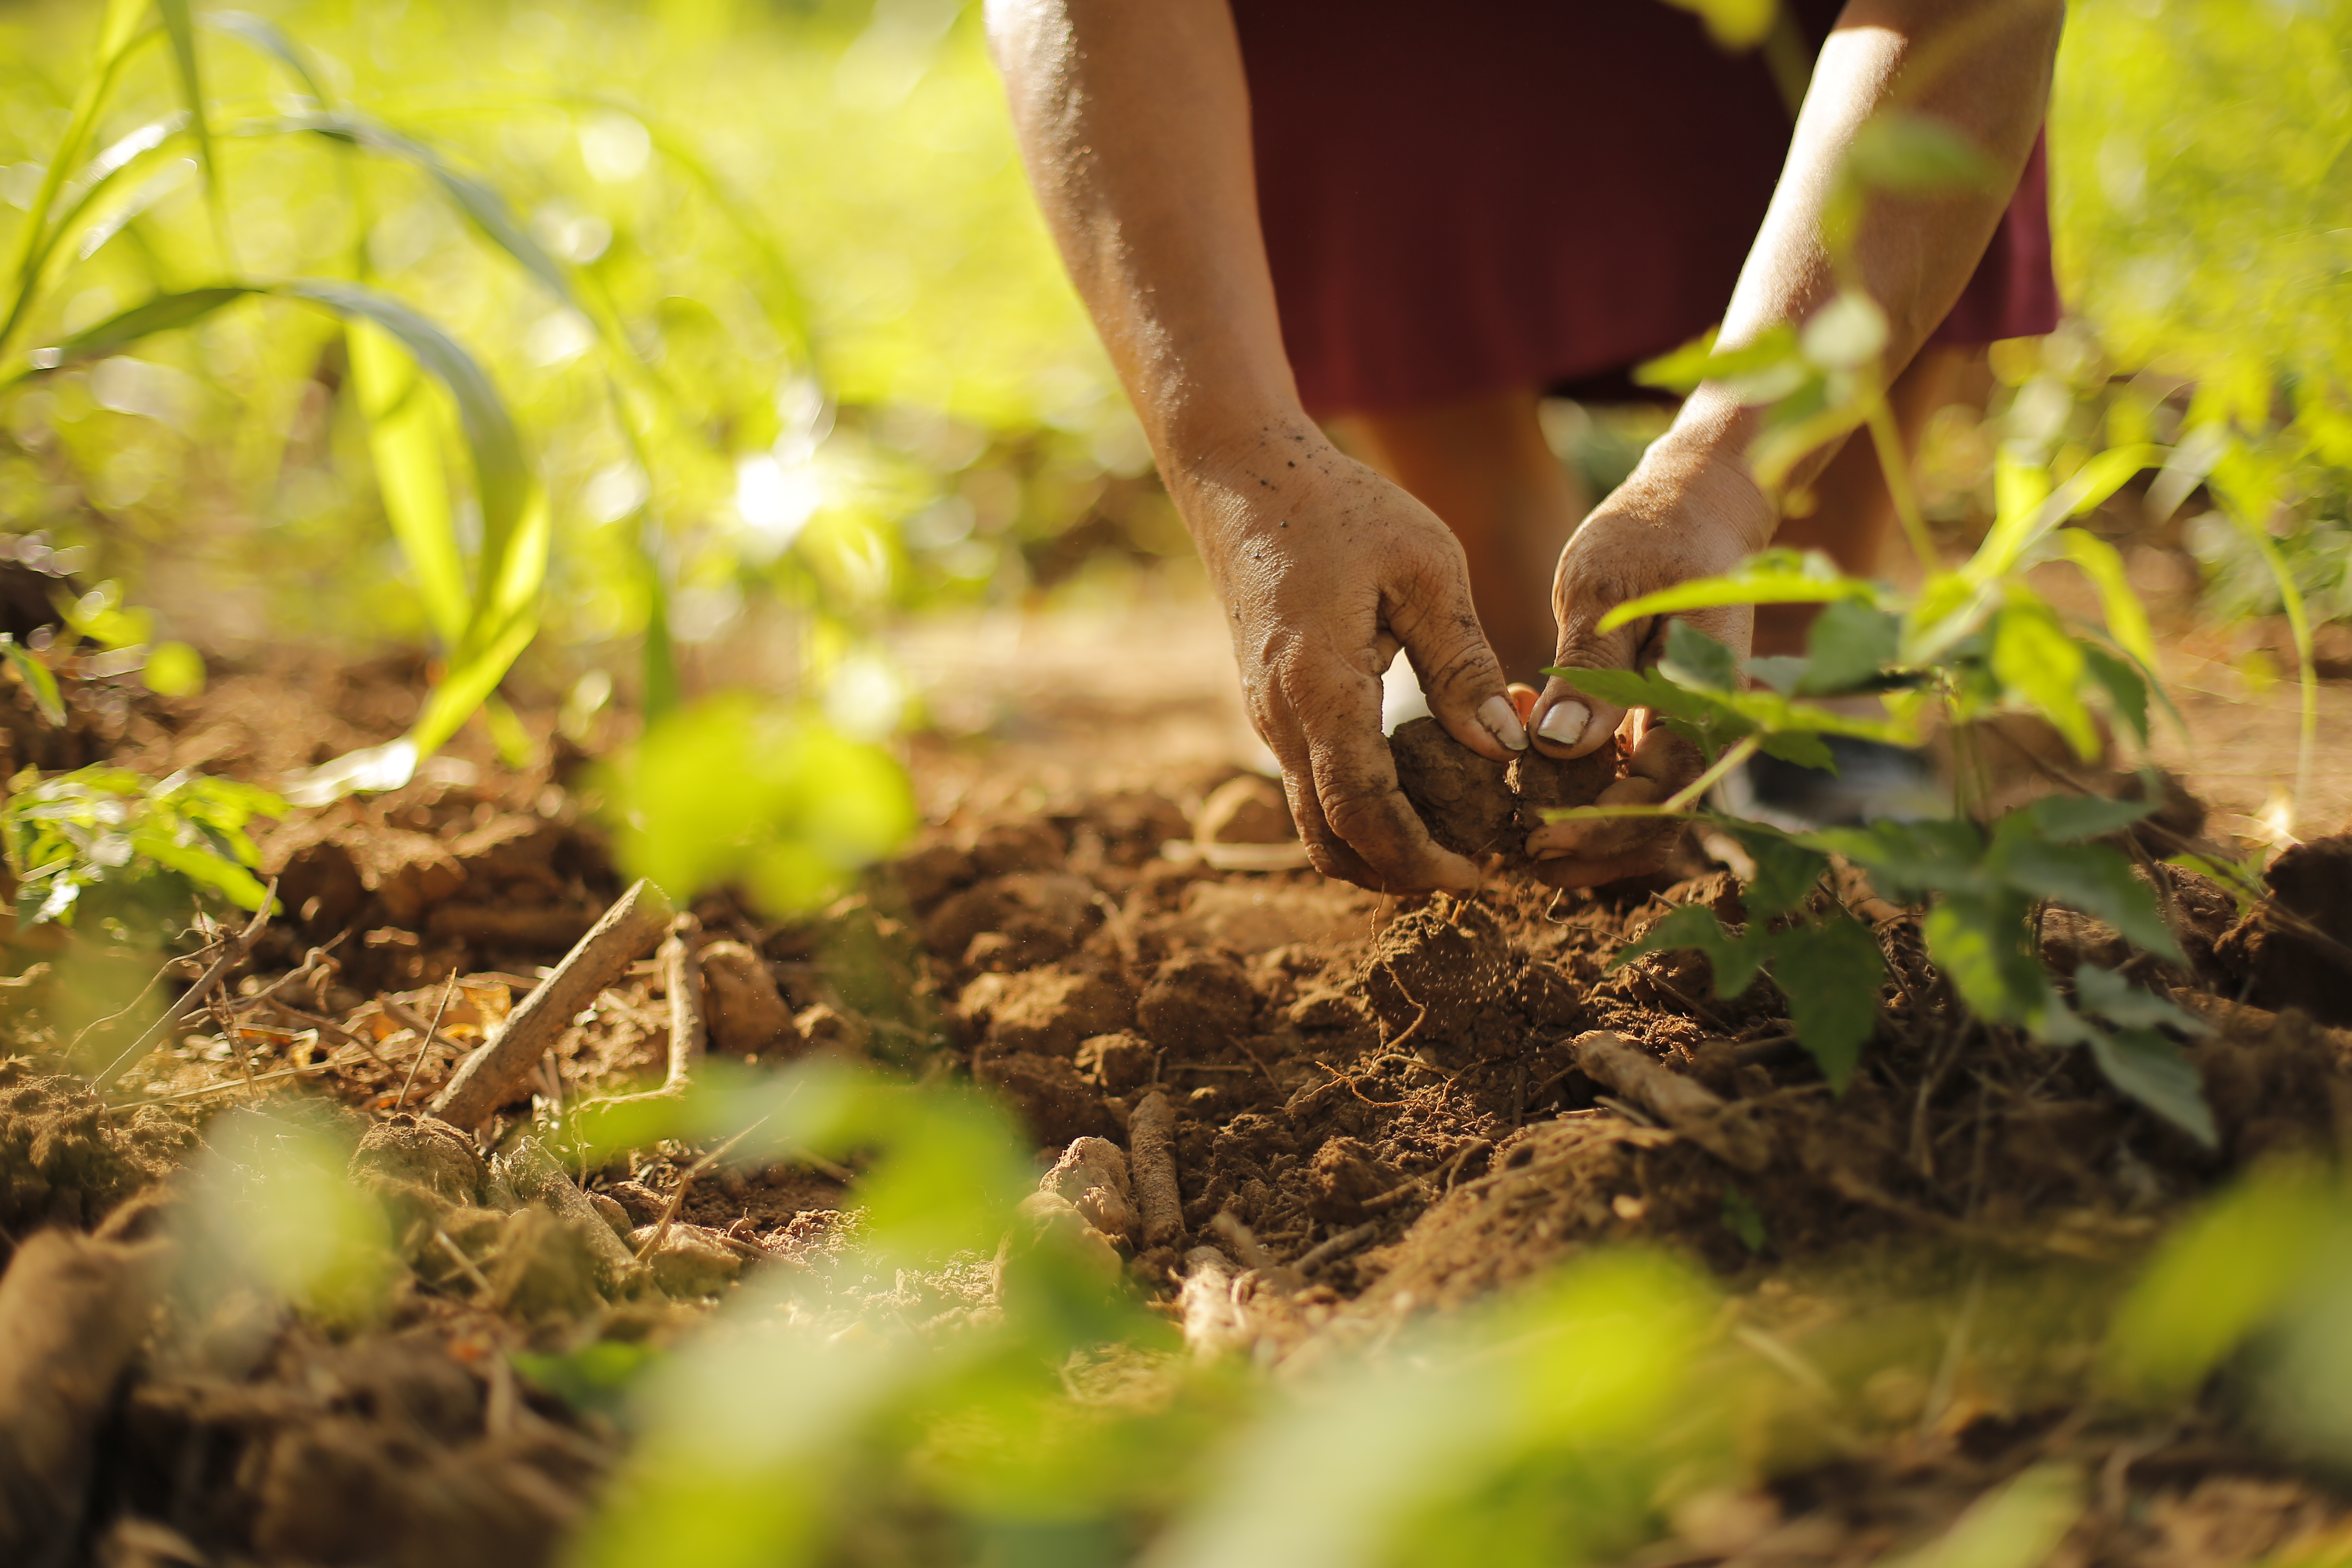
[1552,107,2213,1143]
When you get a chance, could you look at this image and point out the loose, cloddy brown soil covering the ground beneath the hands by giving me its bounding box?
[0,630,2352,1563]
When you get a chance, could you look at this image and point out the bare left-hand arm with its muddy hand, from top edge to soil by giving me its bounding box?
[988,0,1526,891]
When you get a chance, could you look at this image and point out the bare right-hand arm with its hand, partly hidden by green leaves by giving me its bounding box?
[1531,0,2063,884]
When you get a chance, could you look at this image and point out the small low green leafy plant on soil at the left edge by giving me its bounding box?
[0,766,285,926]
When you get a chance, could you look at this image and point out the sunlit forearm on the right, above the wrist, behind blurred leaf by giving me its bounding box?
[1677,0,2063,484]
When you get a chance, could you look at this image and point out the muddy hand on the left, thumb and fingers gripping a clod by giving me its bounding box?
[1178,425,1526,893]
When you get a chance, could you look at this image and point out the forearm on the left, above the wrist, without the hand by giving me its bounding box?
[988,0,1310,487]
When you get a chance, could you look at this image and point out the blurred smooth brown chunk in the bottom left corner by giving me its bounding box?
[0,1229,169,1568]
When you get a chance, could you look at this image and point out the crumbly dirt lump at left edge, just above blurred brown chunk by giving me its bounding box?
[0,1062,195,1236]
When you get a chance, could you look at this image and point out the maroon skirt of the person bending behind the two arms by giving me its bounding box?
[1232,0,2058,414]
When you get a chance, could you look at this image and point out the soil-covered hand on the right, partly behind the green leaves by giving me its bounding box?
[1526,432,1773,886]
